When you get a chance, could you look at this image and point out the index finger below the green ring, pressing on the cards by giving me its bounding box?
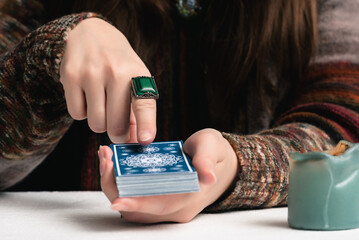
[132,97,156,145]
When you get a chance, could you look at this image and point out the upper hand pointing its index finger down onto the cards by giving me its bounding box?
[60,18,156,145]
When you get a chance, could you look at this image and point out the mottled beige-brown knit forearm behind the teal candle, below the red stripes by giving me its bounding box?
[206,123,334,212]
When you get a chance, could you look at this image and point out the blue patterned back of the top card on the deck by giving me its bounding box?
[111,141,195,177]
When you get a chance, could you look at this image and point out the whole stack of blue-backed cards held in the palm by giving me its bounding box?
[111,141,199,197]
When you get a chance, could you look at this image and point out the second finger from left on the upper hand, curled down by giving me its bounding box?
[85,79,106,133]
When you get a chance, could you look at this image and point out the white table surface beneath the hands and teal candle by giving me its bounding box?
[0,192,359,240]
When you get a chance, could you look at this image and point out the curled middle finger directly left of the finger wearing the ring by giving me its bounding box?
[106,81,131,143]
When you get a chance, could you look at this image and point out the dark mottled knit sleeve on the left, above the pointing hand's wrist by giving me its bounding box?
[0,0,102,189]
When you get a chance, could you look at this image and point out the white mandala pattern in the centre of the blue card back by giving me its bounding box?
[121,153,182,172]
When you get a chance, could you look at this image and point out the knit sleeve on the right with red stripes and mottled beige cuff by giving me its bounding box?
[206,0,359,212]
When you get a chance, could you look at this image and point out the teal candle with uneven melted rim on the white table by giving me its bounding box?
[288,141,359,230]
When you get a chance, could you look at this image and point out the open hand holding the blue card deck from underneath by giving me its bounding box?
[99,129,238,223]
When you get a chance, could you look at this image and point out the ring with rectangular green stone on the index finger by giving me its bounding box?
[131,76,159,99]
